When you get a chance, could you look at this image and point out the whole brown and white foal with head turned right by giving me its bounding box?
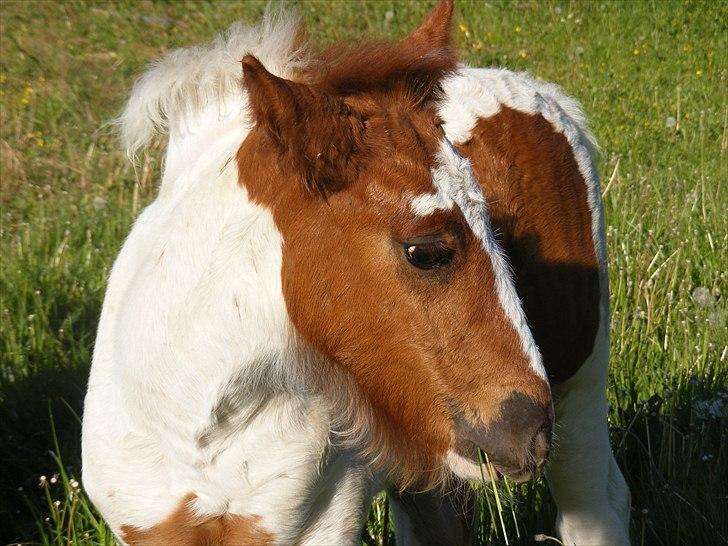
[82,0,629,545]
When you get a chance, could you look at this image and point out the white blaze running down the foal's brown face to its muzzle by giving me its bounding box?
[411,139,546,381]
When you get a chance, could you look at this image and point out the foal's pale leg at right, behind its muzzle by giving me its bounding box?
[546,328,630,545]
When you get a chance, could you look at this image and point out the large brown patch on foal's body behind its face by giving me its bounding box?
[458,106,600,382]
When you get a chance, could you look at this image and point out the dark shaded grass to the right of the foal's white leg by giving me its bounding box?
[612,375,728,545]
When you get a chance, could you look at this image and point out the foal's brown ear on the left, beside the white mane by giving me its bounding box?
[241,55,301,147]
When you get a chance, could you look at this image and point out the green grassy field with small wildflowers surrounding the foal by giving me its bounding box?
[0,0,728,545]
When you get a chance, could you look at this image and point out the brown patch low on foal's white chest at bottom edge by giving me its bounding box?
[121,493,275,546]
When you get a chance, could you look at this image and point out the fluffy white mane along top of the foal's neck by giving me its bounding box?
[118,9,310,157]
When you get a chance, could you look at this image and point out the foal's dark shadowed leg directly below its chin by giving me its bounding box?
[389,484,472,546]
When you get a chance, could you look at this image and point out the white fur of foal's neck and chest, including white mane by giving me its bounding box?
[83,16,371,544]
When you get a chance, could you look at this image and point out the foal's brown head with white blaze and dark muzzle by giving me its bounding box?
[237,0,553,480]
